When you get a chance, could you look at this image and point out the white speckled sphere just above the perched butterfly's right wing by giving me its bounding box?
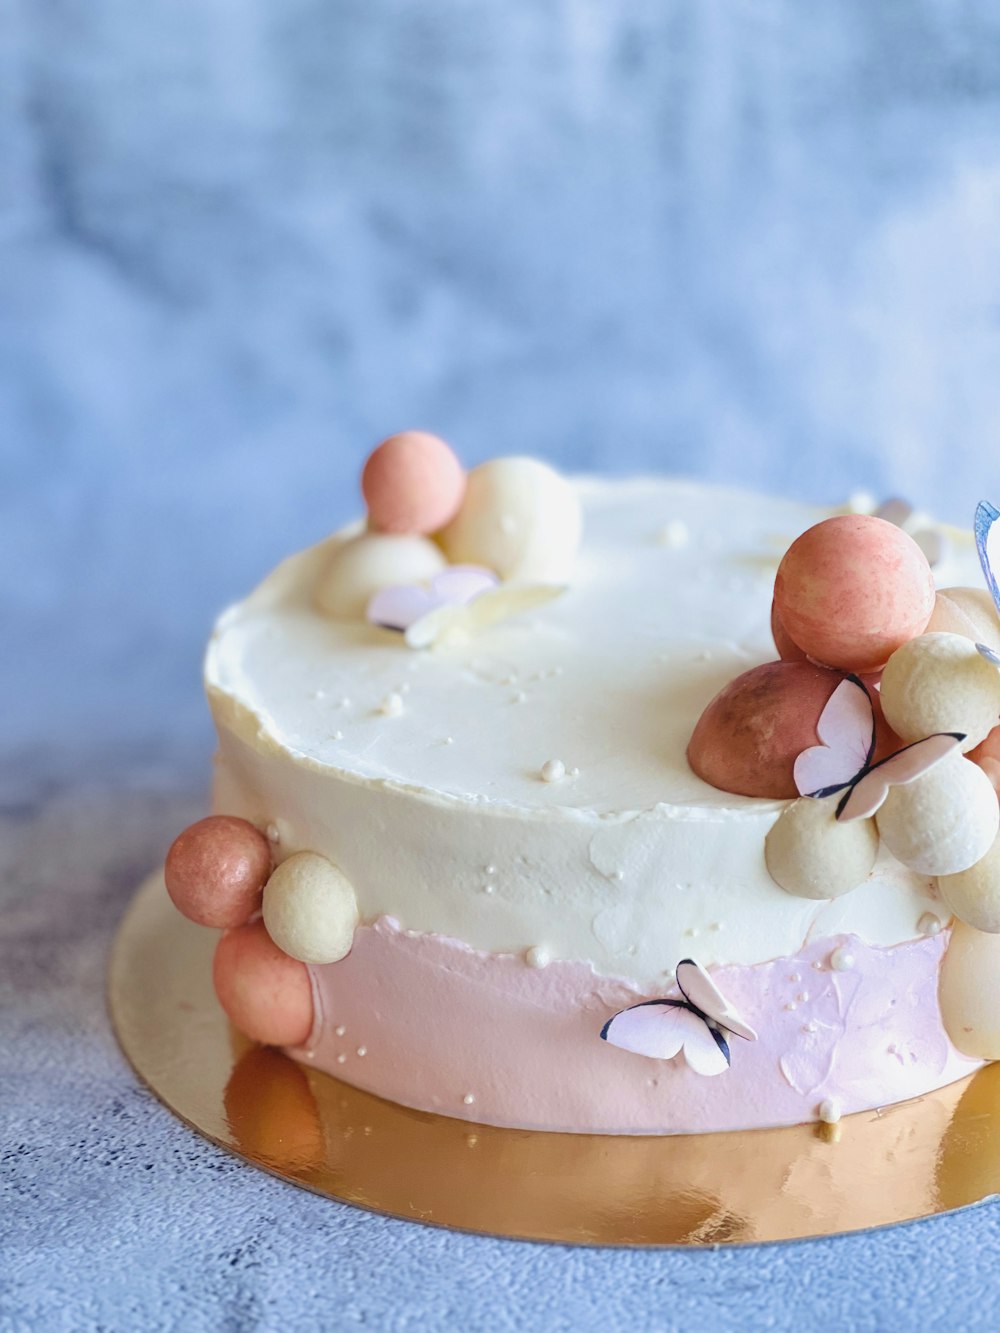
[881,635,1000,750]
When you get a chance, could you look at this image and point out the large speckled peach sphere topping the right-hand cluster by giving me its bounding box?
[775,513,935,672]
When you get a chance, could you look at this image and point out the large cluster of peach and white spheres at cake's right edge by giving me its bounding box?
[688,515,1000,906]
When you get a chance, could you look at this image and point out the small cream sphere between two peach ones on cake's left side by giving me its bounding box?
[264,852,359,962]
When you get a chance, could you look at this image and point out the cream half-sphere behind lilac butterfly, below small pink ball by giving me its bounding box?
[316,532,448,620]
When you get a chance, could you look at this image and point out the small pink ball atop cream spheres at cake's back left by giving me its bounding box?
[361,431,465,536]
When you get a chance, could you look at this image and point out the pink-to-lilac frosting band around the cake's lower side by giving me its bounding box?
[293,917,979,1134]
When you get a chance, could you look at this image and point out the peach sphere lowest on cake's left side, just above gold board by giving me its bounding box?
[212,921,312,1046]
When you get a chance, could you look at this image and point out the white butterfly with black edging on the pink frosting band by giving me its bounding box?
[601,958,757,1076]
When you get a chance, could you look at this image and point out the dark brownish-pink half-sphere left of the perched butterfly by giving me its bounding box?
[688,663,843,800]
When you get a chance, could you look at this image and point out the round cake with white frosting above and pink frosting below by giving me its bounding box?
[205,479,979,1133]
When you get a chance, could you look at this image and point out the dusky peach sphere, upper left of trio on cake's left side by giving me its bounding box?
[164,814,271,930]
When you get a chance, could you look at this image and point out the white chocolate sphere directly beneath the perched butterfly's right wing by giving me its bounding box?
[875,753,1000,876]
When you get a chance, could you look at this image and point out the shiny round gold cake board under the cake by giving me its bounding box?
[109,876,1000,1245]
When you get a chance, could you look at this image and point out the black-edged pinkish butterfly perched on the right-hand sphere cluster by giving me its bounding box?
[793,676,965,821]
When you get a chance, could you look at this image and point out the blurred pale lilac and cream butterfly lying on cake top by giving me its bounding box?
[365,565,565,648]
